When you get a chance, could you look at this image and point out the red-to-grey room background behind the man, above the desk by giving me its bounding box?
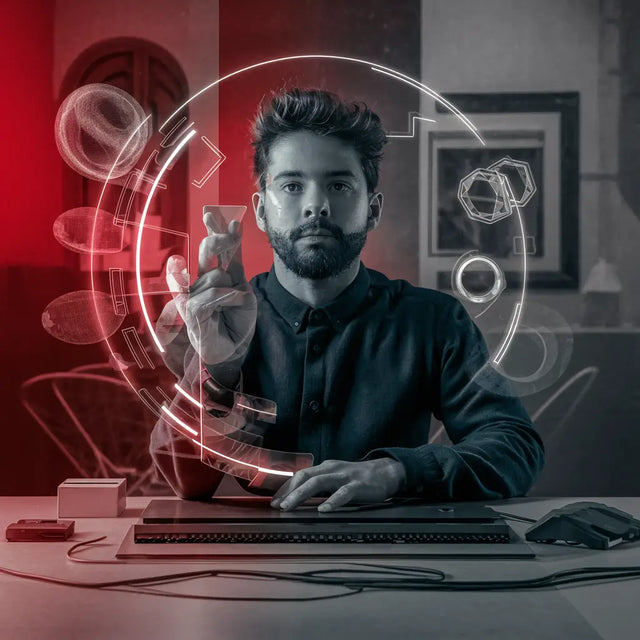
[0,0,640,496]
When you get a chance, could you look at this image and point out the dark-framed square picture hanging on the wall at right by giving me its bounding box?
[421,93,580,289]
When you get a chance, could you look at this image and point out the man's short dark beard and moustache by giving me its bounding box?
[265,218,367,280]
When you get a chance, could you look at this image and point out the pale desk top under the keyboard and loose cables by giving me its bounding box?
[0,497,640,640]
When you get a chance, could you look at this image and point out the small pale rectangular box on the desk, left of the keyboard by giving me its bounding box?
[58,478,127,518]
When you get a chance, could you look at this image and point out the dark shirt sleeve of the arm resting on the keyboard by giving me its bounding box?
[367,300,544,500]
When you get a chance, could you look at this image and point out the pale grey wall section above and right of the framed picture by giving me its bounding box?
[421,0,601,324]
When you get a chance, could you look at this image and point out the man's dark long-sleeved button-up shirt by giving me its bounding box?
[152,265,544,500]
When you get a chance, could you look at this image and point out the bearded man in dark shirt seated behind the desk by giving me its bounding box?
[151,89,544,510]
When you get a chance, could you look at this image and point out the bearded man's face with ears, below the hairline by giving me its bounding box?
[256,131,382,280]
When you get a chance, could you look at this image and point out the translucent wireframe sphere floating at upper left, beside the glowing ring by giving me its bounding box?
[55,83,151,181]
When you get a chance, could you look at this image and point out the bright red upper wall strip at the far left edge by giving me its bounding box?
[0,0,64,266]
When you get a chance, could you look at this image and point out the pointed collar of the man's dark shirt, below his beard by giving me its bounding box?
[265,263,370,333]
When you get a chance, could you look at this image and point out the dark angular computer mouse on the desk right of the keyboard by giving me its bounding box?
[525,502,640,549]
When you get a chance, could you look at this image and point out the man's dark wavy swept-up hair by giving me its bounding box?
[251,89,387,193]
